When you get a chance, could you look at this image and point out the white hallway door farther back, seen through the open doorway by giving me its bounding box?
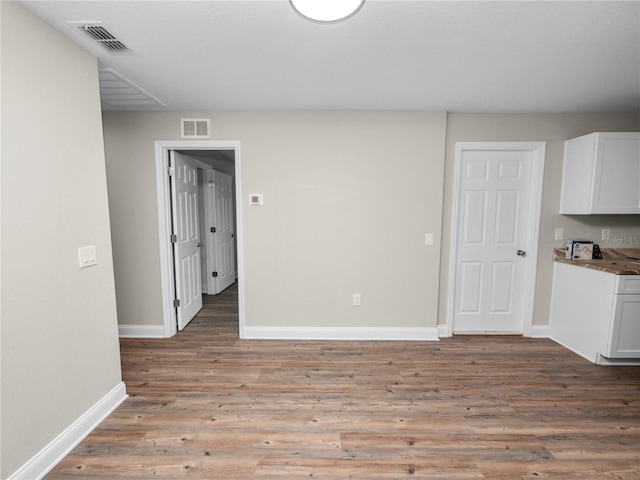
[212,170,236,294]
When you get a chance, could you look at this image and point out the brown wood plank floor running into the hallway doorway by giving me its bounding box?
[46,288,640,480]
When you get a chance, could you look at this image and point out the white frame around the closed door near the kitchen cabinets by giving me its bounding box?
[446,142,546,337]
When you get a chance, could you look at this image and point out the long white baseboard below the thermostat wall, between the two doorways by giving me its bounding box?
[243,325,439,341]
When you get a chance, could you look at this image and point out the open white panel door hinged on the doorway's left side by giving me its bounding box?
[170,151,202,330]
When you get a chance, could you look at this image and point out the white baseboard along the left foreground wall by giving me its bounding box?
[8,382,127,480]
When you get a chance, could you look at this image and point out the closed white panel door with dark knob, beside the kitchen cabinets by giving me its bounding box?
[453,149,534,334]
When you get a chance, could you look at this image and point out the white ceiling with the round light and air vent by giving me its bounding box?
[21,0,640,112]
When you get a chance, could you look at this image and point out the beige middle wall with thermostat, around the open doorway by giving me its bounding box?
[104,112,446,327]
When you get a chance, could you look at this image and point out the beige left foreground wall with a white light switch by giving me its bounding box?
[0,1,121,478]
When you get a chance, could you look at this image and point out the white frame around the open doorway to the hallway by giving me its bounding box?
[154,140,245,338]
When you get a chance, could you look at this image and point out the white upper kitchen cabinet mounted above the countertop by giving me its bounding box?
[560,132,640,215]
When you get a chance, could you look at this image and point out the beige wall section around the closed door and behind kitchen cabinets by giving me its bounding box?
[438,114,640,325]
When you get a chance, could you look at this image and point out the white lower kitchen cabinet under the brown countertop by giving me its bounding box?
[549,262,640,365]
